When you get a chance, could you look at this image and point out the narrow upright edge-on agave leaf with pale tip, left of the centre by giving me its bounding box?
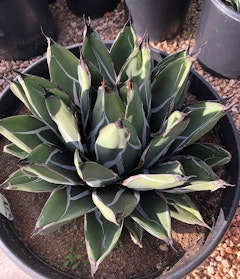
[78,57,91,130]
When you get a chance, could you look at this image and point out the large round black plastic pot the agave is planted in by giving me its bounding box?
[0,45,240,279]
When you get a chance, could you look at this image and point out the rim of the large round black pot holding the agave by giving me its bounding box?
[0,43,240,279]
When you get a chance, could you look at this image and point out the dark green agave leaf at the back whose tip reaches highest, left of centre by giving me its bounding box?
[82,24,116,87]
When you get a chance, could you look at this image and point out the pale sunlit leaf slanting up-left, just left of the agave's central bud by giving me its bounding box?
[46,96,83,152]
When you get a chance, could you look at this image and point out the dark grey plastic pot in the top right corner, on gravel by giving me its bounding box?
[195,0,240,78]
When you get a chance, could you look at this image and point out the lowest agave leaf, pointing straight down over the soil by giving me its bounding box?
[85,210,123,276]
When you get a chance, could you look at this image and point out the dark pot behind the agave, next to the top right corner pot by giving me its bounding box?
[125,0,191,41]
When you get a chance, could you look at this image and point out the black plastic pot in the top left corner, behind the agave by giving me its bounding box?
[0,0,57,60]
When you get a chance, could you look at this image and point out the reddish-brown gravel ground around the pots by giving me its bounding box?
[0,0,240,279]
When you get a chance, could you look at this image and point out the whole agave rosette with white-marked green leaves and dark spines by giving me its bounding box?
[0,23,231,275]
